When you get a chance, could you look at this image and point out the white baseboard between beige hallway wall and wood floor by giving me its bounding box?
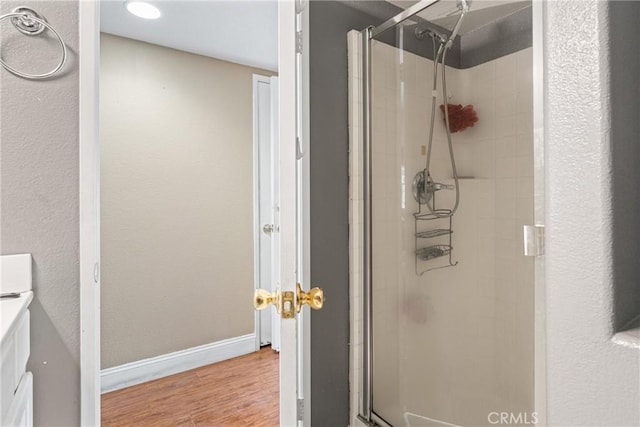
[100,334,256,393]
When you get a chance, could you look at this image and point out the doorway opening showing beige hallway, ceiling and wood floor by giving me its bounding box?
[100,2,279,425]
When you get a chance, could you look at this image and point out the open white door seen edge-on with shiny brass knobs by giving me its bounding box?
[254,1,324,427]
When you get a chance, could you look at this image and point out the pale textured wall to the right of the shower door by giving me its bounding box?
[544,0,640,426]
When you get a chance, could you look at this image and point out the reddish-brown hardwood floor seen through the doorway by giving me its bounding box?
[102,347,280,427]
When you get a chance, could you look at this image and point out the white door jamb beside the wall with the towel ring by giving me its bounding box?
[78,1,100,426]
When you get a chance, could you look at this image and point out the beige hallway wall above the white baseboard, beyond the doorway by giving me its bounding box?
[100,34,273,368]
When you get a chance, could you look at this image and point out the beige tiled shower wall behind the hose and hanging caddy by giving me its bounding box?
[349,32,534,425]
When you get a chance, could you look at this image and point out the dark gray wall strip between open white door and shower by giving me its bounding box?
[309,1,382,427]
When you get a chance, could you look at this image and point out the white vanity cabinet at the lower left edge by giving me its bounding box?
[0,255,33,427]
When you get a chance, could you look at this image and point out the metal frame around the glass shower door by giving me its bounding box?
[354,0,547,426]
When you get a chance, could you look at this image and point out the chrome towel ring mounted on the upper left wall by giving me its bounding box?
[0,6,67,80]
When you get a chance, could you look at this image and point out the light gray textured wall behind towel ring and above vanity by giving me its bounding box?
[0,1,80,426]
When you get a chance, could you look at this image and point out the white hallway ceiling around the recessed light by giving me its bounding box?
[100,0,278,71]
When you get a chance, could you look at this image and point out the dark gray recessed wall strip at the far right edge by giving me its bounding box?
[609,1,640,330]
